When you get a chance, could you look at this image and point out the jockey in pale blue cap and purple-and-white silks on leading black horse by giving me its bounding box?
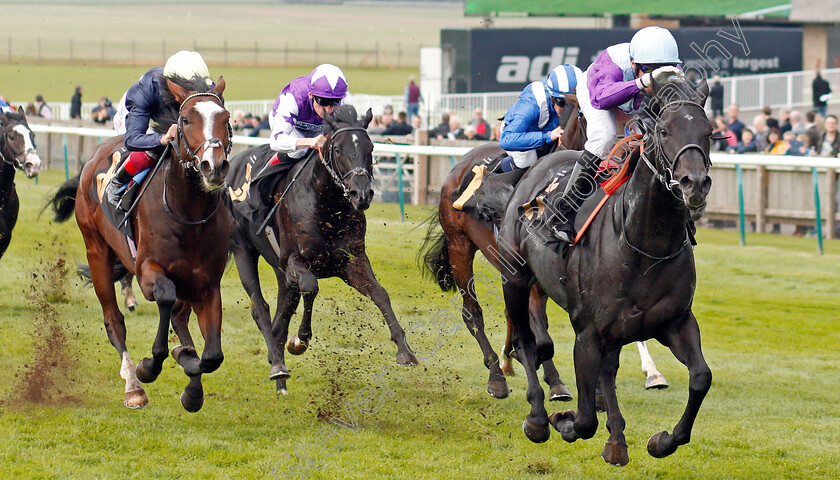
[546,27,682,243]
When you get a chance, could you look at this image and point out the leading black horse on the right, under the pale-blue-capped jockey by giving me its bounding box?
[498,78,712,465]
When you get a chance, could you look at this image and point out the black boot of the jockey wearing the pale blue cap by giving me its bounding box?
[546,150,601,243]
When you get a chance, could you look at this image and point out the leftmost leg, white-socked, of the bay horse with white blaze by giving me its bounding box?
[79,229,149,408]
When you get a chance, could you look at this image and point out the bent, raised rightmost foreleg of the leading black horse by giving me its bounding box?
[648,312,712,458]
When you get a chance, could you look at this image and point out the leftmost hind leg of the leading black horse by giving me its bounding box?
[504,281,551,443]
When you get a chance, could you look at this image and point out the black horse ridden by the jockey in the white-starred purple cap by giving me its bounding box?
[227,105,417,394]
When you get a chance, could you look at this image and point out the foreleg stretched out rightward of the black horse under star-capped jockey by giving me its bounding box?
[342,252,417,366]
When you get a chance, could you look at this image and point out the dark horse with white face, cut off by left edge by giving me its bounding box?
[0,112,41,257]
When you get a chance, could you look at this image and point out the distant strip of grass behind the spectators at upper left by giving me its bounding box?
[0,64,418,103]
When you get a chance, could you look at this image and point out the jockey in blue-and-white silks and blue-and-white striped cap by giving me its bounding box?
[499,65,584,172]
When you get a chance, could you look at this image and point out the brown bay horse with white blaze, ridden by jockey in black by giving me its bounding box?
[53,78,231,412]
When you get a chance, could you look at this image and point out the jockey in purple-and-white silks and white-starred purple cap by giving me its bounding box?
[268,63,347,163]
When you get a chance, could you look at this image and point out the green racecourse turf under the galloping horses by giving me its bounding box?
[0,171,840,479]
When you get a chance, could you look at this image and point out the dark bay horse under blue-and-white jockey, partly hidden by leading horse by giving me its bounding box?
[419,95,668,401]
